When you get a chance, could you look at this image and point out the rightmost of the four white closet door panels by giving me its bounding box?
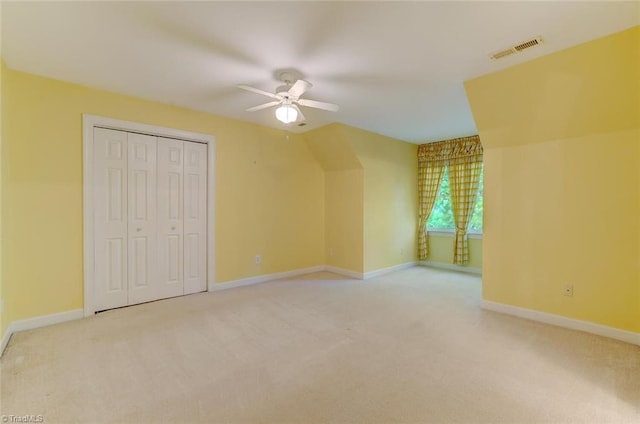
[184,142,207,294]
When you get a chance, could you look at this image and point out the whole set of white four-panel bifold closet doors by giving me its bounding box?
[94,128,207,311]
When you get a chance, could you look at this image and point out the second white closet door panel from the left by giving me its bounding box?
[127,133,158,304]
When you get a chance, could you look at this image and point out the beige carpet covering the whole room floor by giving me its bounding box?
[1,267,640,424]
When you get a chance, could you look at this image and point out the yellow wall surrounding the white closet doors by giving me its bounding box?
[2,69,325,327]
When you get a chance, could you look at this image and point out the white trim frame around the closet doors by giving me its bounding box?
[82,113,215,317]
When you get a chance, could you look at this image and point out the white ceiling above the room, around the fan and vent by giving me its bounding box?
[2,1,640,143]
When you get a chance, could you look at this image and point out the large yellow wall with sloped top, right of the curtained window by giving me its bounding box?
[465,27,640,332]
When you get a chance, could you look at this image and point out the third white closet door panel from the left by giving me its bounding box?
[157,138,184,298]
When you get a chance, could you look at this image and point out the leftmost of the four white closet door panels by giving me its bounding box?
[93,128,128,311]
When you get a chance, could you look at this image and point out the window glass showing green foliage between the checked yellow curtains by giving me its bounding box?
[427,167,484,233]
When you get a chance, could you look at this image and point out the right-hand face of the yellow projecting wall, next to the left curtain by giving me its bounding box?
[341,125,418,272]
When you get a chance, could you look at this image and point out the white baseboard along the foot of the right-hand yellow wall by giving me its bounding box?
[481,300,640,346]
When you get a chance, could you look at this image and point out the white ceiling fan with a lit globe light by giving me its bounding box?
[238,72,339,124]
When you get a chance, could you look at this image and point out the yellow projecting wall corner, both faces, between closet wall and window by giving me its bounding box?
[305,124,418,272]
